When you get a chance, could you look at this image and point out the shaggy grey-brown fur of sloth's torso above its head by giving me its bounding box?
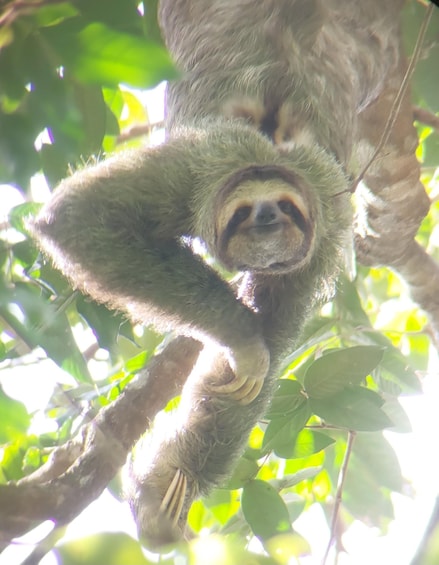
[160,0,403,164]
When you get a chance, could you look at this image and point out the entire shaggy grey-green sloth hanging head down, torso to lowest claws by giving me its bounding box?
[32,0,434,545]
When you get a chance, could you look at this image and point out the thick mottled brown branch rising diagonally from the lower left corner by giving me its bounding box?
[0,337,201,546]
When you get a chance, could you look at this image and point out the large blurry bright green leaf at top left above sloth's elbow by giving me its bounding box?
[42,22,176,88]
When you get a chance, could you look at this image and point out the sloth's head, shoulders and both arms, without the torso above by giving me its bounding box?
[31,122,351,545]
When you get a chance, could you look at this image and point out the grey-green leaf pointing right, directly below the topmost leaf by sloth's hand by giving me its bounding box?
[309,386,392,432]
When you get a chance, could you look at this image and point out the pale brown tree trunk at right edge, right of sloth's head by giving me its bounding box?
[355,44,439,337]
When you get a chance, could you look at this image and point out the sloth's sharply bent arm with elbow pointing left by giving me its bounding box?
[31,122,304,386]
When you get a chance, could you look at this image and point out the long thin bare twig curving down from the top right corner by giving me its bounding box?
[351,3,434,192]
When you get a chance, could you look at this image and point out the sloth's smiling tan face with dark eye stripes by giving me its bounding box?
[216,180,314,273]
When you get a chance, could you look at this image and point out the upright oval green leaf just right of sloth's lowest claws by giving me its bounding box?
[241,480,291,541]
